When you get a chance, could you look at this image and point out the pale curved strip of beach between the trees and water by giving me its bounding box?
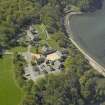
[64,12,105,77]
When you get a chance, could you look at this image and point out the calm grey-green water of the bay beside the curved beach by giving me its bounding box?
[70,2,105,67]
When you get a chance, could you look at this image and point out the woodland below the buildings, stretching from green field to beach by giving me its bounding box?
[14,43,105,105]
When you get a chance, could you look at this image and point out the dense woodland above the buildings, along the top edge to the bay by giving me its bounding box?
[0,0,102,47]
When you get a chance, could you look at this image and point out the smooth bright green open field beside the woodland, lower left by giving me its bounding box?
[0,55,24,105]
